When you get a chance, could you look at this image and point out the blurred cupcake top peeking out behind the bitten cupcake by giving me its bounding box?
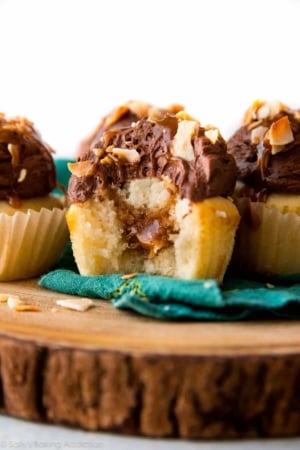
[78,100,184,156]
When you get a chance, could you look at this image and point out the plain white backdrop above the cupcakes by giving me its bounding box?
[0,0,300,157]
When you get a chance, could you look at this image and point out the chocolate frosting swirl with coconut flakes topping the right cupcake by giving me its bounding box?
[227,101,300,199]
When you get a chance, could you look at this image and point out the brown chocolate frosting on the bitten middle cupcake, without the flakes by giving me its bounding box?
[68,114,236,202]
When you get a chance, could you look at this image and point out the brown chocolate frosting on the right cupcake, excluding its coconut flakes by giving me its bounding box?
[227,110,300,195]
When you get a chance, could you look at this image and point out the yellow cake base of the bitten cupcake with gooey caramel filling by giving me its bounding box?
[67,178,239,280]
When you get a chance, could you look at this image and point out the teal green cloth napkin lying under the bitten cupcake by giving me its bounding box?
[39,160,300,321]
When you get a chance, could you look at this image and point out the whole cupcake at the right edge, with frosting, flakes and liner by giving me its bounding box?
[228,100,300,275]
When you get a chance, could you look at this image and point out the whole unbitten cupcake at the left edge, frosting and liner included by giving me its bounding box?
[0,113,69,281]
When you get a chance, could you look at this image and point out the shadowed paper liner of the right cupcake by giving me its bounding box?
[233,199,300,275]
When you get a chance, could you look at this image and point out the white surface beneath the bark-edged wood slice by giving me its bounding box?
[0,416,300,450]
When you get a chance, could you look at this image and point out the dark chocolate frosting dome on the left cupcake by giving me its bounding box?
[0,114,56,206]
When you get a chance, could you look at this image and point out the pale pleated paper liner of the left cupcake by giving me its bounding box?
[0,208,69,281]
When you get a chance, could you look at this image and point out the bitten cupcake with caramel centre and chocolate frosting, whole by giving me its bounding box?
[67,111,240,282]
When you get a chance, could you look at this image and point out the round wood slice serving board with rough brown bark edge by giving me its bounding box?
[0,280,300,439]
